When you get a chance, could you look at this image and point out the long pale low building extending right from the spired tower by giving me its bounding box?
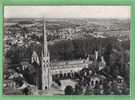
[51,59,92,75]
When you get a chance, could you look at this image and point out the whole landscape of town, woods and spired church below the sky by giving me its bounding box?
[3,18,130,95]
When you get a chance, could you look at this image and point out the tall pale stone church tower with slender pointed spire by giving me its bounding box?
[42,19,52,90]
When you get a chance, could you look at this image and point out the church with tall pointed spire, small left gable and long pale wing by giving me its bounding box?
[31,18,90,90]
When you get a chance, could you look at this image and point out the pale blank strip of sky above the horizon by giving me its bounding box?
[4,6,131,19]
